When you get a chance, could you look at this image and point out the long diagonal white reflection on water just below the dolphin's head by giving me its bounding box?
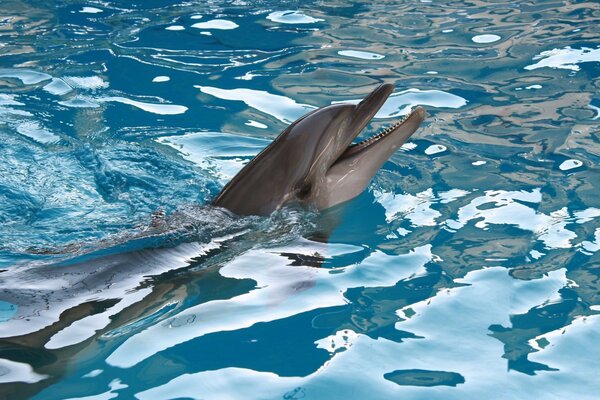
[107,242,431,368]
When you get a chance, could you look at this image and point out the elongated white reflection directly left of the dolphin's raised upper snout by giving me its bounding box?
[199,86,316,124]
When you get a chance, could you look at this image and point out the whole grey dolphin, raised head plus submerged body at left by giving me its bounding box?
[0,84,425,397]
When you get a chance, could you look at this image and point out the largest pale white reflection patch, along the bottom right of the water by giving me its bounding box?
[135,268,584,400]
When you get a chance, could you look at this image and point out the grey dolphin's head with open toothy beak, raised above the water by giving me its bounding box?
[213,84,426,215]
